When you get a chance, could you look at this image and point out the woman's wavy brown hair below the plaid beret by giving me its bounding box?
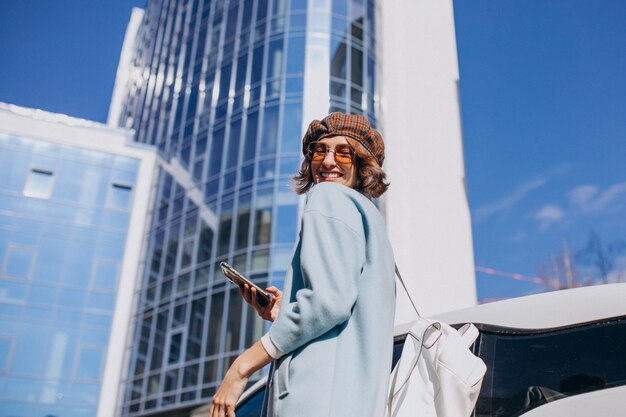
[292,137,389,198]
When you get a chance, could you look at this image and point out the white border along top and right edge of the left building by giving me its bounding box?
[0,103,157,417]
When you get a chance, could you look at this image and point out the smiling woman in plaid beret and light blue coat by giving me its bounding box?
[210,113,395,417]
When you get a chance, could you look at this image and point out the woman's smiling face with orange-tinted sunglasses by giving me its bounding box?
[311,136,357,188]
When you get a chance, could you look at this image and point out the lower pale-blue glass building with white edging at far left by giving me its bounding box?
[0,103,155,417]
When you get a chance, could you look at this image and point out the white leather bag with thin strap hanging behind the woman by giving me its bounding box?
[385,267,487,417]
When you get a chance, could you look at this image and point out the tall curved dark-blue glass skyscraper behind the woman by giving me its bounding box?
[110,0,377,416]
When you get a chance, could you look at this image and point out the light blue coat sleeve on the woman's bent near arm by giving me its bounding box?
[269,190,365,353]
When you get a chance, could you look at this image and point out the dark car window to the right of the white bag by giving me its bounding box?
[475,318,626,417]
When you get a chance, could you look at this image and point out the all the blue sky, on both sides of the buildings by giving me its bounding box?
[0,0,626,299]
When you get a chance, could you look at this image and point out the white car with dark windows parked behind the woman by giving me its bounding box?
[229,283,626,417]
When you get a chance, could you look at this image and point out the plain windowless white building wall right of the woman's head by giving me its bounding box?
[379,0,476,323]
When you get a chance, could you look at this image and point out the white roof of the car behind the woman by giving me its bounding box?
[395,283,626,335]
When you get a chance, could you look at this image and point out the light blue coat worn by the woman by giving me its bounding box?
[267,183,395,417]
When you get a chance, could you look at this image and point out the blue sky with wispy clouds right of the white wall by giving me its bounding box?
[454,0,626,298]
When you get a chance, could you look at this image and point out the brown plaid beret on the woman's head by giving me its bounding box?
[302,113,385,167]
